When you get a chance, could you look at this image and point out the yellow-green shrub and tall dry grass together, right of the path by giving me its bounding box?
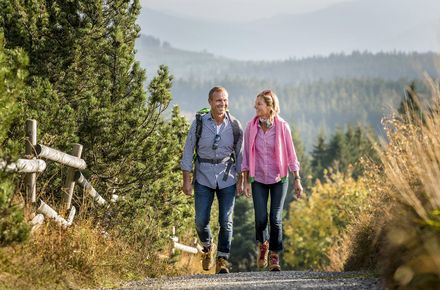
[285,79,440,289]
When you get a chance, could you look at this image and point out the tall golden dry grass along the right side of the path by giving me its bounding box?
[329,79,440,289]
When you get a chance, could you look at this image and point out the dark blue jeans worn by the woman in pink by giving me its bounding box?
[252,181,288,252]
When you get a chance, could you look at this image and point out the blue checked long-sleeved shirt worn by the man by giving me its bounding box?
[180,113,243,189]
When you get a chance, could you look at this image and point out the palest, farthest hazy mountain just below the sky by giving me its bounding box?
[138,0,440,60]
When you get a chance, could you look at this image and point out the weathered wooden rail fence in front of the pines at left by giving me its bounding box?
[0,120,110,231]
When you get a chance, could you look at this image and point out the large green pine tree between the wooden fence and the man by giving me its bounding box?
[0,0,190,246]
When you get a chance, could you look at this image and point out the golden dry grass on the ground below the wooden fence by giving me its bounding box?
[0,207,184,289]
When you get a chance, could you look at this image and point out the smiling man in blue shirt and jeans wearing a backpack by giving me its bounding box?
[180,87,243,273]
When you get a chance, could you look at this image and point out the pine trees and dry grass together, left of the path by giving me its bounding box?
[0,0,194,289]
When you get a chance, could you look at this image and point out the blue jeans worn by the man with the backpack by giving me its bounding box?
[194,181,236,258]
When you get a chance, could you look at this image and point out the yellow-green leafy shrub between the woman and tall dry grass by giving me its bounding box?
[284,172,368,270]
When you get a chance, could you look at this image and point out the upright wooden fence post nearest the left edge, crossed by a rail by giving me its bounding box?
[25,119,37,203]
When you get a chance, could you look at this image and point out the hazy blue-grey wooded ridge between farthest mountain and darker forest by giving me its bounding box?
[136,35,440,85]
